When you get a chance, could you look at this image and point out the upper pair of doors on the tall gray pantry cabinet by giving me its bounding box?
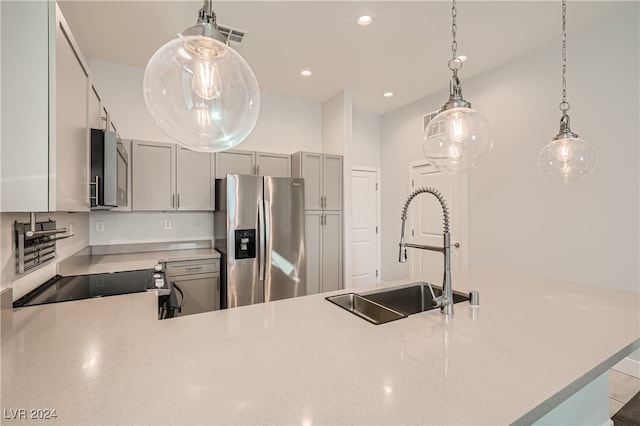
[291,152,342,210]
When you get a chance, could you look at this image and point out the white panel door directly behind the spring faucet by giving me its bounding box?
[405,165,467,285]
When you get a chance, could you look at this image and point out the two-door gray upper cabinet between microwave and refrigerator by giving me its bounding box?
[131,141,214,211]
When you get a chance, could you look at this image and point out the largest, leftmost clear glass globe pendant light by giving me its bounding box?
[142,0,260,152]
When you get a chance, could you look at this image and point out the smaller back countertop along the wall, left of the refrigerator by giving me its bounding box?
[58,248,220,275]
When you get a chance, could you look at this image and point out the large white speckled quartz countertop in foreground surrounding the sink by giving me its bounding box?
[2,271,640,425]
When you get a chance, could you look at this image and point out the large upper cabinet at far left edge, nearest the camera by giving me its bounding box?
[0,1,89,212]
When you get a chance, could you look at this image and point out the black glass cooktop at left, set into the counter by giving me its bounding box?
[13,269,154,308]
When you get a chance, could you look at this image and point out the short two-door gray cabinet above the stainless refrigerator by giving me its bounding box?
[216,149,291,179]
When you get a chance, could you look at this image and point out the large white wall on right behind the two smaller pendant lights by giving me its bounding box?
[381,3,640,292]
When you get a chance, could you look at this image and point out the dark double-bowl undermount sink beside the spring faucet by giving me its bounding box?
[326,282,469,324]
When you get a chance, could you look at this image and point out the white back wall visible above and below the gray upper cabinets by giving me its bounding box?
[90,59,322,245]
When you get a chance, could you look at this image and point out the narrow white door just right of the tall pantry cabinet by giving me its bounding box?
[351,170,379,287]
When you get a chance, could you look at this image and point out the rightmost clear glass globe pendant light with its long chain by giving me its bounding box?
[538,0,596,183]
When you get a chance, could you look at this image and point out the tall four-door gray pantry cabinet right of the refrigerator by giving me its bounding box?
[291,151,344,294]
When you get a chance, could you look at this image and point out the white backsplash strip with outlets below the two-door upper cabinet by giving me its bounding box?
[89,211,213,246]
